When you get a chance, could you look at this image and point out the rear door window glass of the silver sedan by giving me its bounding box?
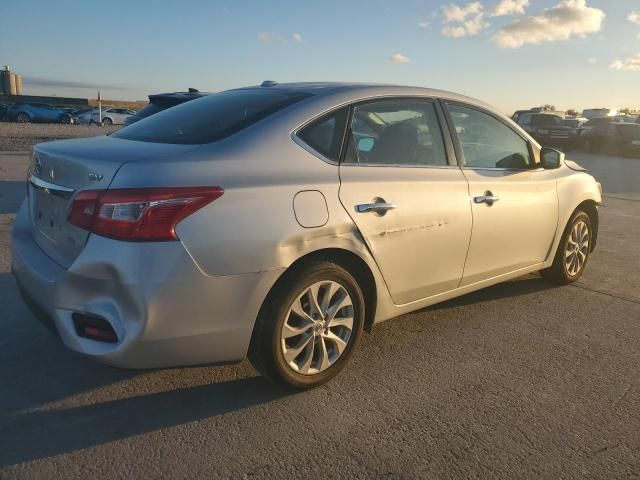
[345,100,447,165]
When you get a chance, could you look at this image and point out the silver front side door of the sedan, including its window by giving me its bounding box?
[447,103,558,286]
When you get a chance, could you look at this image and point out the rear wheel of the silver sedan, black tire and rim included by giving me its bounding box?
[249,261,365,389]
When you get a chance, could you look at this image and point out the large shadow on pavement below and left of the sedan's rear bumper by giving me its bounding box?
[0,272,292,468]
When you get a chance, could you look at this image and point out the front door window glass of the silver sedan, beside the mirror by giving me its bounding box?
[449,105,532,169]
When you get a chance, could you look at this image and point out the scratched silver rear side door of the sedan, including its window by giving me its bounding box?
[340,99,471,304]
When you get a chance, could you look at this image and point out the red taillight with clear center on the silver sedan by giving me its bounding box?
[68,187,224,241]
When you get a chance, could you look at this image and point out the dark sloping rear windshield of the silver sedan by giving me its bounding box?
[111,88,310,144]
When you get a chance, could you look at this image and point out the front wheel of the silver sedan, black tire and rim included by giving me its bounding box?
[540,210,593,285]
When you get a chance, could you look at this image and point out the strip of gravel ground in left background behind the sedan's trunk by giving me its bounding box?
[0,122,120,151]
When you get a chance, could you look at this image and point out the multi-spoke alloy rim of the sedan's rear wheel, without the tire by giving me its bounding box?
[280,281,354,375]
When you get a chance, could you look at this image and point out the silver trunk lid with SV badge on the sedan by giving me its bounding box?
[28,136,198,268]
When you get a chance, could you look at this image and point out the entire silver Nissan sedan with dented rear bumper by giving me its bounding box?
[12,82,601,388]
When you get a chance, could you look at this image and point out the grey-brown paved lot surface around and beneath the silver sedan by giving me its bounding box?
[0,129,640,479]
